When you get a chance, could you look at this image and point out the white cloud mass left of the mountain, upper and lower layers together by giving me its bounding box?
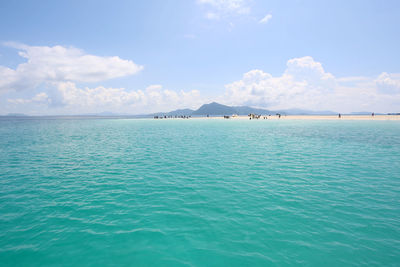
[0,43,209,114]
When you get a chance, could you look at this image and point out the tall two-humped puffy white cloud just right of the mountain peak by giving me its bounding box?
[226,57,335,106]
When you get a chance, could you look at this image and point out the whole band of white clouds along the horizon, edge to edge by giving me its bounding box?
[0,43,400,114]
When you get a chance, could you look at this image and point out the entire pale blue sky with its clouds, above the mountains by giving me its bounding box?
[0,0,400,115]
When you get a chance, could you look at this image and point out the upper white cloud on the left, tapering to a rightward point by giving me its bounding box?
[0,43,143,92]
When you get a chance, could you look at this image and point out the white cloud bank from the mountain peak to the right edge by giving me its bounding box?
[219,57,400,112]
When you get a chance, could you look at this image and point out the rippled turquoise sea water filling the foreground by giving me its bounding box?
[0,118,400,266]
